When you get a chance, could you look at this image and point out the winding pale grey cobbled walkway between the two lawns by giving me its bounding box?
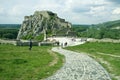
[46,48,111,80]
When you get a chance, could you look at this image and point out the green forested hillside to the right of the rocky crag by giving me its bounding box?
[72,20,120,39]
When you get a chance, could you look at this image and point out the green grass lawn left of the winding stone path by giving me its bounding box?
[0,45,64,80]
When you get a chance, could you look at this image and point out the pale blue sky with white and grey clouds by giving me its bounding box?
[0,0,120,24]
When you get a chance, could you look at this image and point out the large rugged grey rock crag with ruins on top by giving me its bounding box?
[17,11,71,39]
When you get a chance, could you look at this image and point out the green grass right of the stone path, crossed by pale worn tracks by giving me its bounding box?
[66,42,120,80]
